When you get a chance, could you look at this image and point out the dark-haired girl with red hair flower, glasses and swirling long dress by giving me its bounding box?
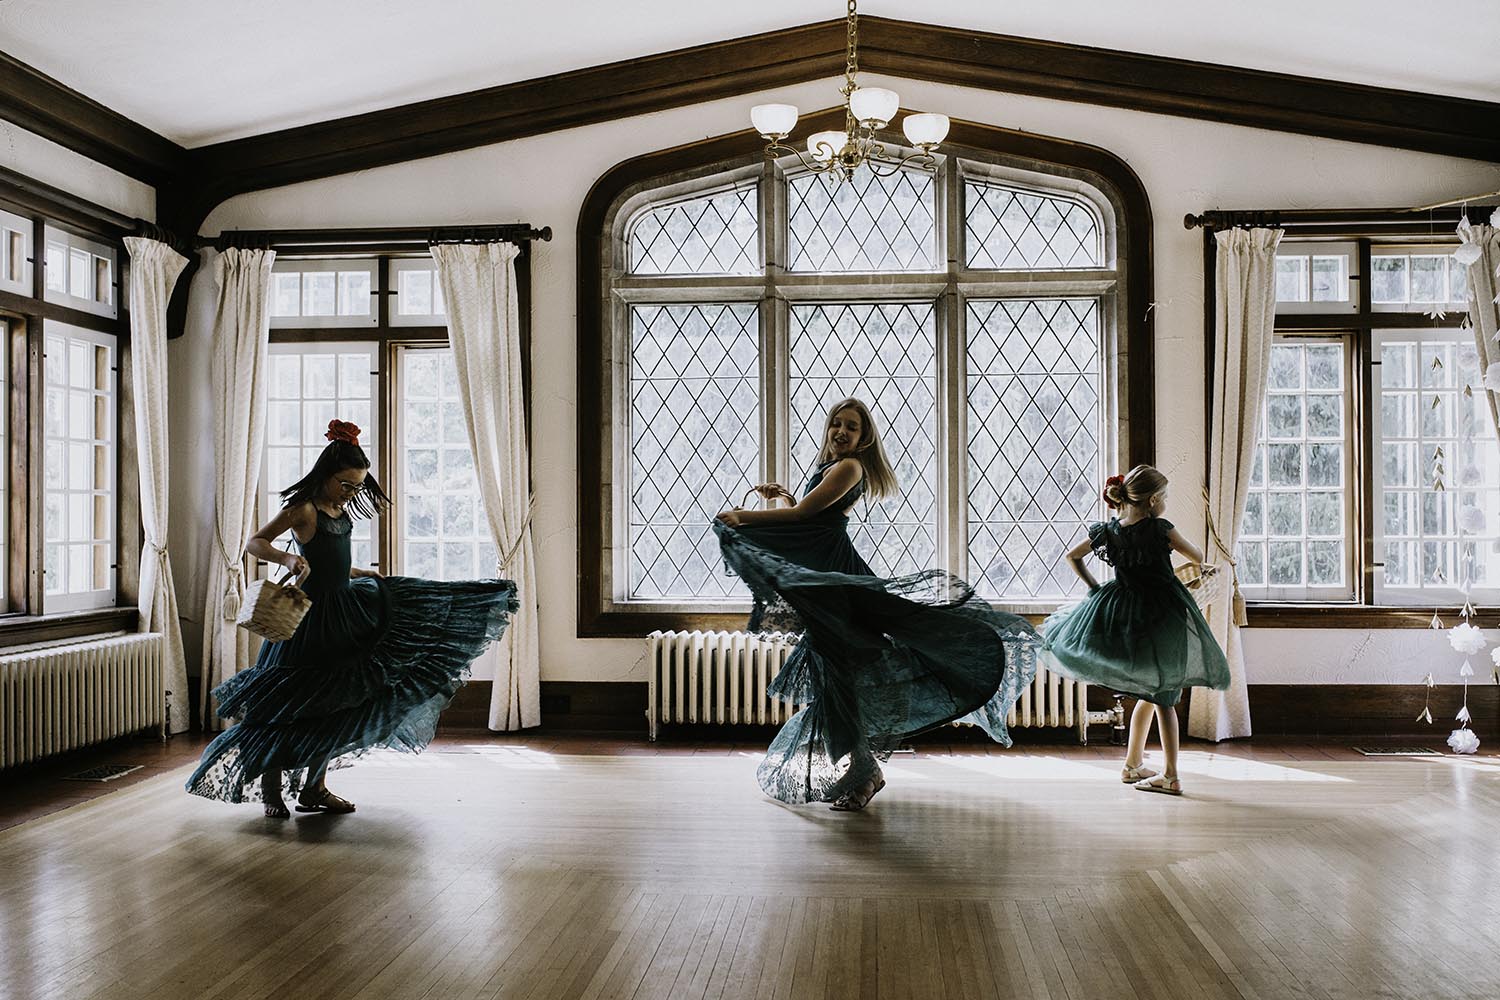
[188,420,516,819]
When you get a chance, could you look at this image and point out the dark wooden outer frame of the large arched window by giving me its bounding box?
[578,111,1155,637]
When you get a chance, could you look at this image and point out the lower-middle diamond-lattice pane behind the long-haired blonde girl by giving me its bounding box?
[791,303,938,576]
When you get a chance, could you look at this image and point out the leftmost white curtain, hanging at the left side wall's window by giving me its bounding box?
[125,237,192,733]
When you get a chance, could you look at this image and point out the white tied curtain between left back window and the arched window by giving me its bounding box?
[432,243,542,730]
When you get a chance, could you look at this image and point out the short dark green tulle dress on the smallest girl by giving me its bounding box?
[1041,517,1229,705]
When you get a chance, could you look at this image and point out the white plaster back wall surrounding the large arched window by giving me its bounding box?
[171,78,1500,682]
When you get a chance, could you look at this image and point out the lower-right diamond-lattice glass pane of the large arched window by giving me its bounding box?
[968,298,1106,601]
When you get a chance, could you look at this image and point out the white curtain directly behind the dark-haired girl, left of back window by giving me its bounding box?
[200,249,276,730]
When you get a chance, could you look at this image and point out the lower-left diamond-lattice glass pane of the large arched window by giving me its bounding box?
[627,303,761,600]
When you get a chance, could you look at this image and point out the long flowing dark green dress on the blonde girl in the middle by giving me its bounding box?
[714,462,1040,802]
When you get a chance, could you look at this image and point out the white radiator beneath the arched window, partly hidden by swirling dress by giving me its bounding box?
[647,631,1113,744]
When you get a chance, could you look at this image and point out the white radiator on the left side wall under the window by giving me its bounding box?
[0,633,167,768]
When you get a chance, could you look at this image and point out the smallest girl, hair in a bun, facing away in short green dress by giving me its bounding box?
[1043,465,1229,795]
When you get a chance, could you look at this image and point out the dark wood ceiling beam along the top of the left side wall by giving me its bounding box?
[0,52,188,184]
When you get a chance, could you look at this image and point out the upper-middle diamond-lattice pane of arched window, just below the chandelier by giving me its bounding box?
[786,169,938,271]
